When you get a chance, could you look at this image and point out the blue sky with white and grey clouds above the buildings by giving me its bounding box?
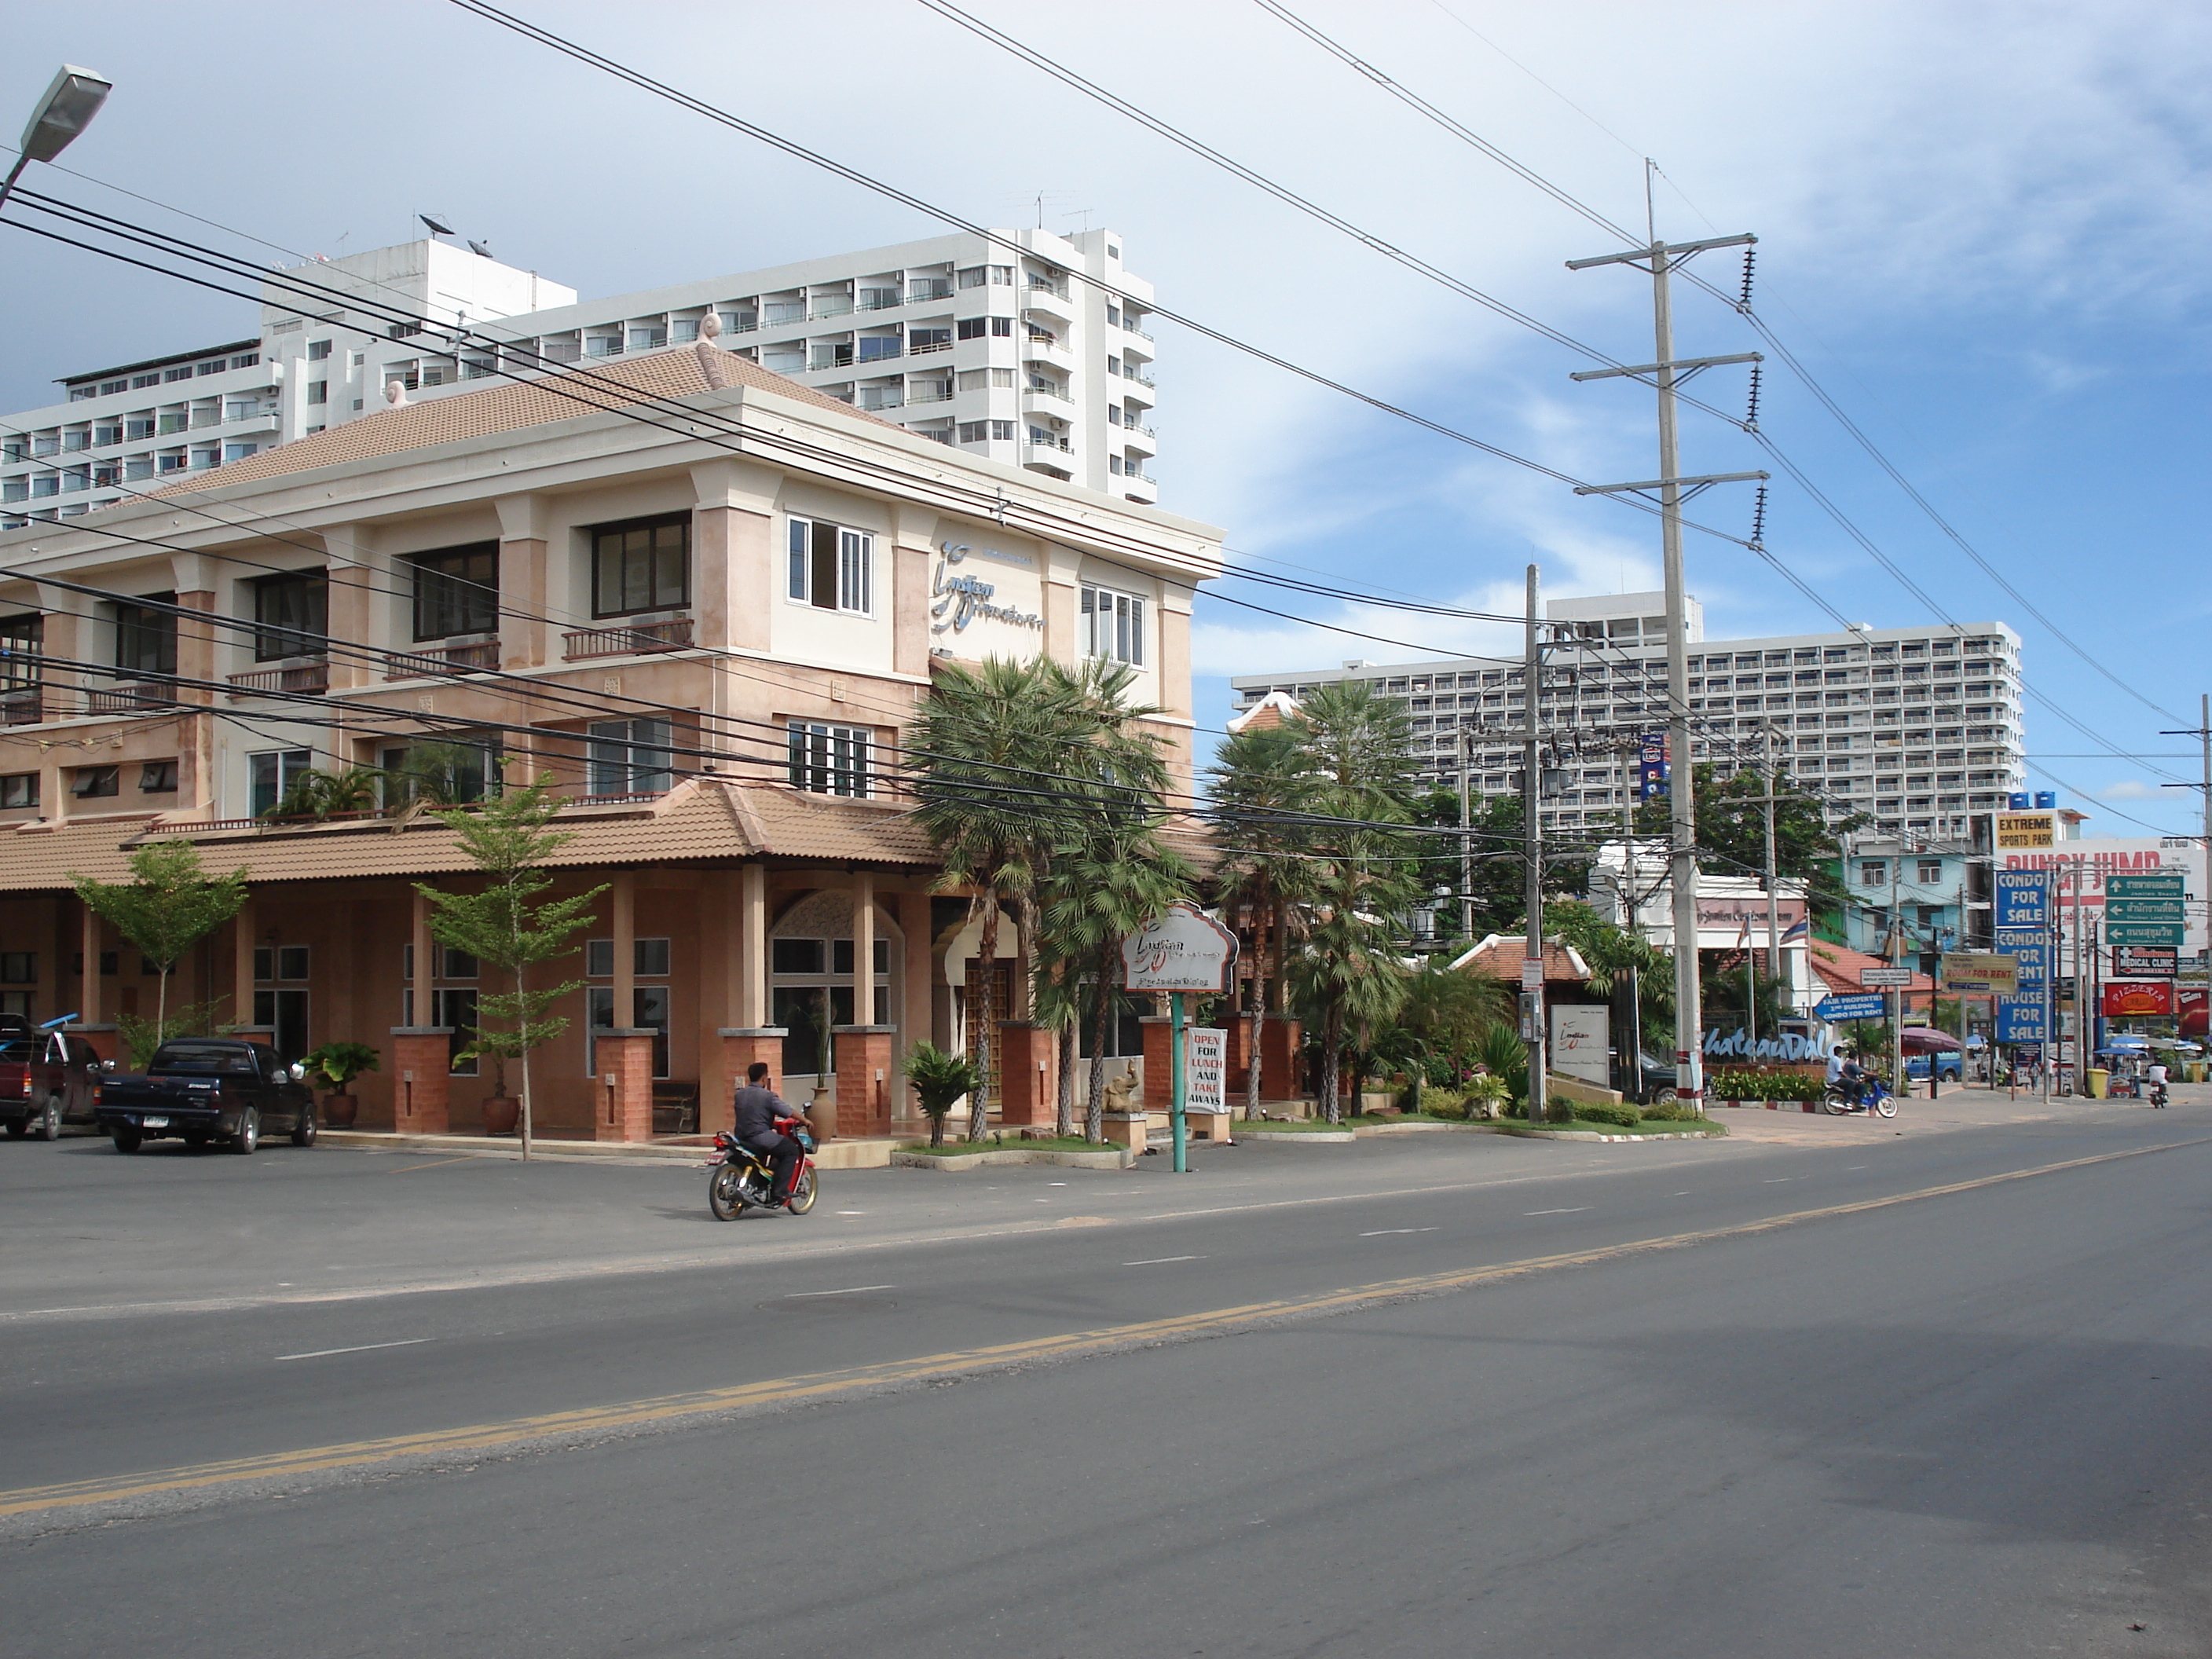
[0,0,2212,834]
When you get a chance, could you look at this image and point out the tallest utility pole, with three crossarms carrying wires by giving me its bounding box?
[1566,224,1767,1111]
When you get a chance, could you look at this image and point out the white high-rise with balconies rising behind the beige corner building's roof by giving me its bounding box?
[0,230,1159,526]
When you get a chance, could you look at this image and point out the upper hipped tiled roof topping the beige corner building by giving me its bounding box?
[133,341,895,500]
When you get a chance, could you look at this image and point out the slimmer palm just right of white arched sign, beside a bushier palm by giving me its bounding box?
[1208,726,1318,1119]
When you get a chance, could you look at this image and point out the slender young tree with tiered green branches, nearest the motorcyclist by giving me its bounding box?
[416,778,606,1159]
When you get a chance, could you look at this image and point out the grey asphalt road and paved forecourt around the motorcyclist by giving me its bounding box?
[0,1090,2212,1659]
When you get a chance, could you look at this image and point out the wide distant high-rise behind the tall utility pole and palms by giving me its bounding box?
[1230,593,2026,838]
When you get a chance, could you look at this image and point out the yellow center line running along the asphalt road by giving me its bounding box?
[0,1137,2212,1518]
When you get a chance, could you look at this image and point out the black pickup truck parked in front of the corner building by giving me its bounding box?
[95,1038,314,1152]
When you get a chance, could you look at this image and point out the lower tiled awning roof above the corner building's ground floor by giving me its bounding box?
[0,778,938,894]
